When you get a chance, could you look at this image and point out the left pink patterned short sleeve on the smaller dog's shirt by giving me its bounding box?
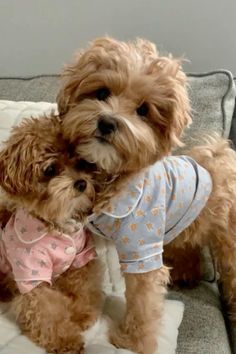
[7,243,52,294]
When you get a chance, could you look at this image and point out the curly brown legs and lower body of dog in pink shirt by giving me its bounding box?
[11,261,102,353]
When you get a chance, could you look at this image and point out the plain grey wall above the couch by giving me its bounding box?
[0,0,236,76]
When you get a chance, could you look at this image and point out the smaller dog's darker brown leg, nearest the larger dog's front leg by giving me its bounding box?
[56,260,103,331]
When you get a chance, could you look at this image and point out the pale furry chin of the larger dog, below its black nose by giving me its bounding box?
[76,138,122,174]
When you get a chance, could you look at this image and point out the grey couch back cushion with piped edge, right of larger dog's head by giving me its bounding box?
[185,70,236,145]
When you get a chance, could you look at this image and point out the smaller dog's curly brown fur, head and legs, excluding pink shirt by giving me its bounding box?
[0,114,102,353]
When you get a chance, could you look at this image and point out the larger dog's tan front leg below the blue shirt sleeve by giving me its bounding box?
[110,267,169,354]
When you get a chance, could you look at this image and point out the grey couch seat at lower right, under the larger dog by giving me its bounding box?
[169,282,231,354]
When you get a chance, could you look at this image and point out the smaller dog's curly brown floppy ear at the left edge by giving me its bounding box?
[0,134,33,195]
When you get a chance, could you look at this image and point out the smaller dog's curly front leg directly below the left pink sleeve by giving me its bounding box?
[11,284,83,354]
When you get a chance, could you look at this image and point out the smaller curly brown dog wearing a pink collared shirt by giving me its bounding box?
[0,114,102,353]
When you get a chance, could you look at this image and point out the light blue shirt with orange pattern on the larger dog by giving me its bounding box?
[88,156,212,273]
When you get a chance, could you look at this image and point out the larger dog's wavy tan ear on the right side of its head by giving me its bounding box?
[149,56,192,151]
